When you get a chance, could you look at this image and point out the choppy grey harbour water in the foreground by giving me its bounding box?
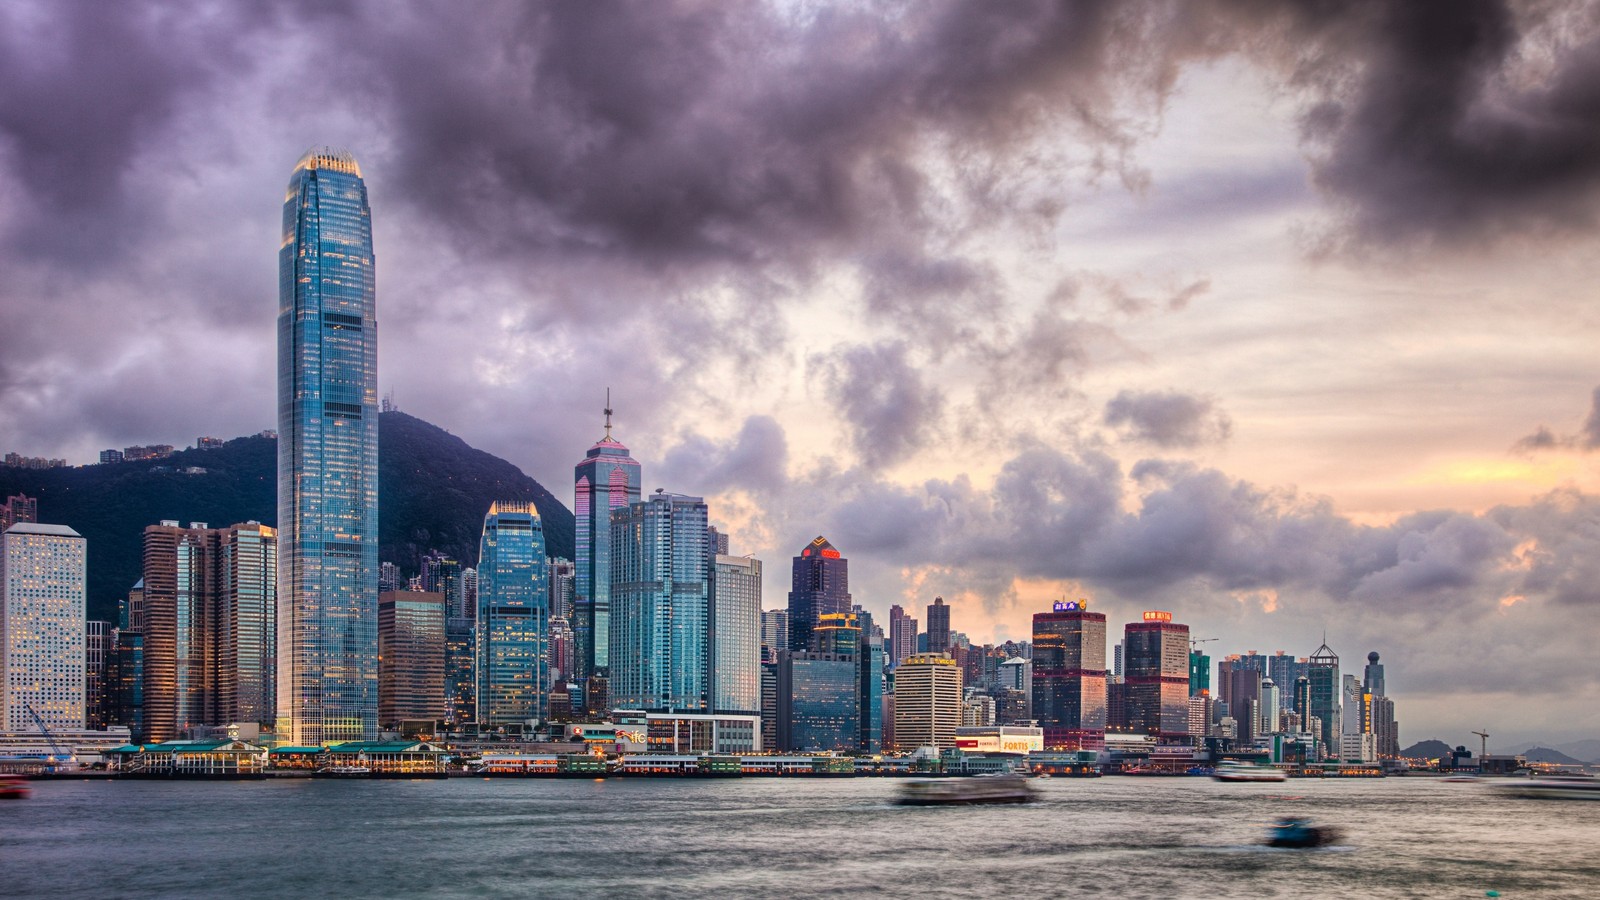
[0,778,1600,898]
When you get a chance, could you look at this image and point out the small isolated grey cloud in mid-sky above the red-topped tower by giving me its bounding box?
[806,341,944,466]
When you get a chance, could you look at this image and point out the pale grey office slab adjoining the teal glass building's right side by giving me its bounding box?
[706,550,762,716]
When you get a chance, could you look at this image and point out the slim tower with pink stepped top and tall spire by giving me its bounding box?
[571,391,640,682]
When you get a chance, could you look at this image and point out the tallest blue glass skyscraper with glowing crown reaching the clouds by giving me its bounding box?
[277,151,378,745]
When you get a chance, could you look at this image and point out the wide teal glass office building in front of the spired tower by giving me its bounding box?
[610,490,710,713]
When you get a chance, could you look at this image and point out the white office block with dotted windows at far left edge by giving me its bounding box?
[0,522,88,732]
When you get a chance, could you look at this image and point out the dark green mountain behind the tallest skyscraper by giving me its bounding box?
[0,412,573,620]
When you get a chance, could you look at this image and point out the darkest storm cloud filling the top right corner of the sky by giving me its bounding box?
[1226,0,1600,247]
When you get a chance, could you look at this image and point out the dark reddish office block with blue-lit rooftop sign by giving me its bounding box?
[1030,601,1106,749]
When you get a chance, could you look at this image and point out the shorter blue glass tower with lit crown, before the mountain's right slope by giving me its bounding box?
[477,501,550,729]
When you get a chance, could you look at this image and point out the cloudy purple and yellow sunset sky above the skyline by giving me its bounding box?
[0,0,1600,743]
